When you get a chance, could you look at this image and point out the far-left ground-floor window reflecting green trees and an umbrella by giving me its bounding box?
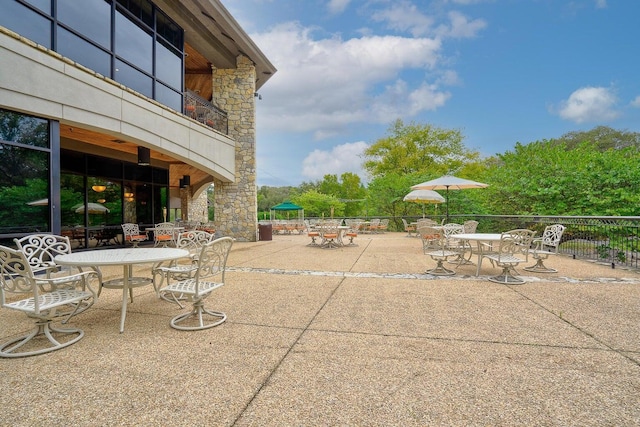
[0,110,51,234]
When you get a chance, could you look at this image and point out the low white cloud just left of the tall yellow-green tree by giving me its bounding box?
[302,141,368,181]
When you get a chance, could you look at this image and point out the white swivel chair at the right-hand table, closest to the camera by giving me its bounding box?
[478,229,535,285]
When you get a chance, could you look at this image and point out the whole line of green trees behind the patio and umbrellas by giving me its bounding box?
[258,120,640,218]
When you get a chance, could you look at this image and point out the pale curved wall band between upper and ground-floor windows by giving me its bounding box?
[0,27,236,182]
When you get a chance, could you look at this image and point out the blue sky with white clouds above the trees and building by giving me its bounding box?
[222,0,640,186]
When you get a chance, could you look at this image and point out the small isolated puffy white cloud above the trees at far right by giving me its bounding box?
[558,86,618,123]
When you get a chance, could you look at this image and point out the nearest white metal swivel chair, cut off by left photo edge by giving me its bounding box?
[0,246,98,357]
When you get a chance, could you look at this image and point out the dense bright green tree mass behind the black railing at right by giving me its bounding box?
[484,140,640,216]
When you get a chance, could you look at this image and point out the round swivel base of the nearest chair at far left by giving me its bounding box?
[0,320,84,357]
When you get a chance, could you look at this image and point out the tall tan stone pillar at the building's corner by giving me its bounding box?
[213,55,258,242]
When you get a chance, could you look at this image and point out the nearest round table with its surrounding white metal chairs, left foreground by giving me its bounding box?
[0,224,233,358]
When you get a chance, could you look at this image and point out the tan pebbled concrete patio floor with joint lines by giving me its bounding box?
[0,233,640,426]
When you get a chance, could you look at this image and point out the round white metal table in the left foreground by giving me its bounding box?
[54,248,189,333]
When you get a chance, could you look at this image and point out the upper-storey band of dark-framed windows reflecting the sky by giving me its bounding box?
[5,0,184,111]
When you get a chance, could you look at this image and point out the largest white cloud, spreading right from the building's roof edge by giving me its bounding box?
[252,23,448,137]
